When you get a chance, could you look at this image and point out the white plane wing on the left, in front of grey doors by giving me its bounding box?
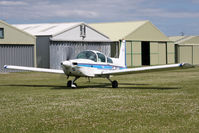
[4,65,64,73]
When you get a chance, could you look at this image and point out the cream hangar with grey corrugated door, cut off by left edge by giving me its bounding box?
[0,20,36,72]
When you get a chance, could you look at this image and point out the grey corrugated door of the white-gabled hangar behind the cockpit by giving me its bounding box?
[50,41,111,69]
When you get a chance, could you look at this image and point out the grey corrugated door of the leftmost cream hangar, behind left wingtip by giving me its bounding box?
[0,45,34,72]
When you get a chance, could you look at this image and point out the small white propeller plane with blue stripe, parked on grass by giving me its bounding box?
[4,40,190,88]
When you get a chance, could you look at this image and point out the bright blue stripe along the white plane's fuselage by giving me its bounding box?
[77,63,126,70]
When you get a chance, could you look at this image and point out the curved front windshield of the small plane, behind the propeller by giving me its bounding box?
[77,51,97,62]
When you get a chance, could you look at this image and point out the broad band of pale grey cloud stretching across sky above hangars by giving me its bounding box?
[0,0,199,21]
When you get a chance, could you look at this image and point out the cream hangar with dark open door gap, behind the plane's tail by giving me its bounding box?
[90,21,175,67]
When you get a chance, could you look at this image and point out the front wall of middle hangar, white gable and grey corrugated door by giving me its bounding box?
[50,24,111,69]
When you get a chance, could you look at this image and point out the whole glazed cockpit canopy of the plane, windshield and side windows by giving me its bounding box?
[77,51,113,63]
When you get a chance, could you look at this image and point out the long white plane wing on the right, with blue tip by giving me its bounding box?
[99,63,192,75]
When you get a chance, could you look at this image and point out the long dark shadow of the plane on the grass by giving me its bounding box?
[0,83,180,90]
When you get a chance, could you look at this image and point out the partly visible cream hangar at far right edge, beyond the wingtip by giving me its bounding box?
[169,36,199,65]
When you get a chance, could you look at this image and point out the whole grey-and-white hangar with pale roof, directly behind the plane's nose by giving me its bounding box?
[14,23,111,69]
